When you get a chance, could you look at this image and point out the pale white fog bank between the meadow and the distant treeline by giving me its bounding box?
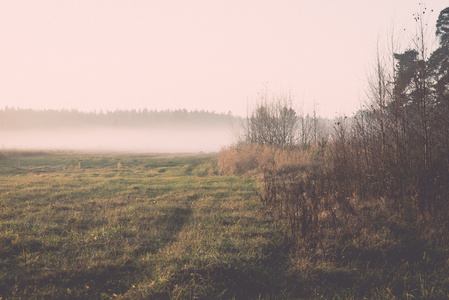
[0,128,234,153]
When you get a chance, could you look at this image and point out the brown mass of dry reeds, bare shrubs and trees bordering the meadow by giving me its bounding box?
[218,8,449,253]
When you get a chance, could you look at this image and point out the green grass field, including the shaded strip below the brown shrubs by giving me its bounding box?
[0,152,449,299]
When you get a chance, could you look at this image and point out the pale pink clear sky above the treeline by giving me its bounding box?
[0,0,449,118]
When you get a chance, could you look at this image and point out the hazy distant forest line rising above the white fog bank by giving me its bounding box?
[0,107,241,130]
